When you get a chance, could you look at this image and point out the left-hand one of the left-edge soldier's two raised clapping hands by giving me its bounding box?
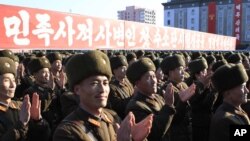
[19,95,31,126]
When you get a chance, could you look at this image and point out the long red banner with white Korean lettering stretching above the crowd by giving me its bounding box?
[0,5,235,50]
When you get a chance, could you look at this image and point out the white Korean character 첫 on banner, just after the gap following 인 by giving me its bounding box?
[139,27,150,48]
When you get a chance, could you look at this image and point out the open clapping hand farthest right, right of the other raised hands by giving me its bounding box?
[179,83,196,102]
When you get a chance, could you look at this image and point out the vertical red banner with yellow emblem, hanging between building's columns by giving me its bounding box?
[207,2,216,33]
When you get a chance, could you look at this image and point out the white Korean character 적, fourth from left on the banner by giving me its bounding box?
[76,19,93,47]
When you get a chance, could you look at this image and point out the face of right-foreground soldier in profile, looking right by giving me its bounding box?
[227,83,249,105]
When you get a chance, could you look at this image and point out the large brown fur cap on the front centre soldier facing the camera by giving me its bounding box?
[66,50,112,90]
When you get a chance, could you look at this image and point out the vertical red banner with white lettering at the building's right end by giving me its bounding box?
[234,0,242,44]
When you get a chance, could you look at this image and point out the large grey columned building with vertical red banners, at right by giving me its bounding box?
[163,0,250,45]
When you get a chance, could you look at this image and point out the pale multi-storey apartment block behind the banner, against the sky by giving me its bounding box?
[118,6,156,24]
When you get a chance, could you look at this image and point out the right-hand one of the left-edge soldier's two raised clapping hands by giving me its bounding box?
[30,93,42,120]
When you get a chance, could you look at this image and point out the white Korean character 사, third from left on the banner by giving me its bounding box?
[54,16,75,46]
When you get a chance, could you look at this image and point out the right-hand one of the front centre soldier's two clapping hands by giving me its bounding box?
[131,114,153,141]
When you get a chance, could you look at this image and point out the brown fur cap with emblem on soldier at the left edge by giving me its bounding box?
[0,57,17,76]
